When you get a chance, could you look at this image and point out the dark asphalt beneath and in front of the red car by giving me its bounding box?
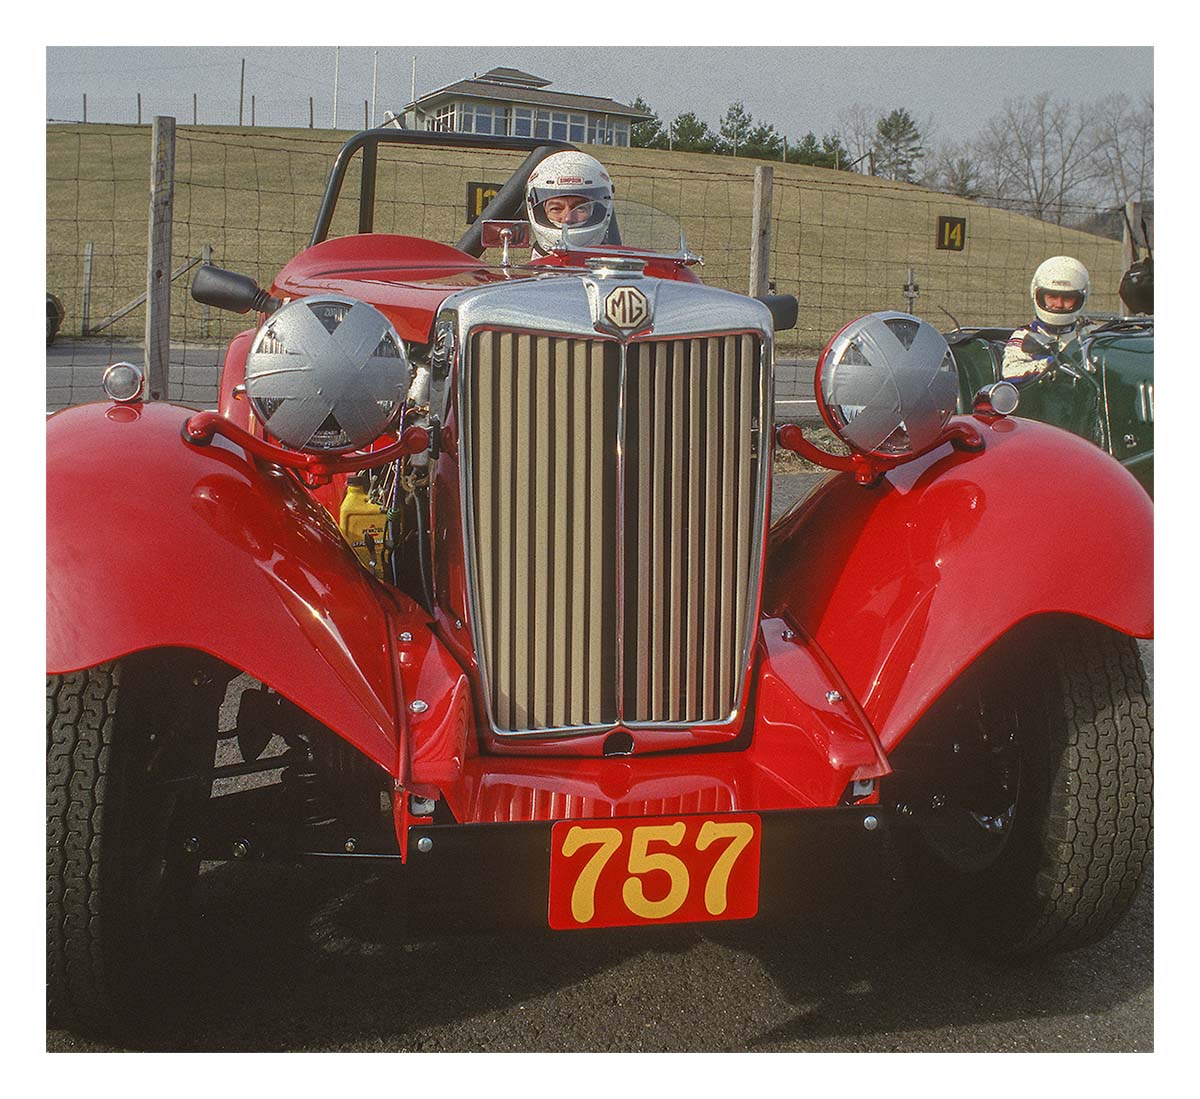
[47,475,1154,1055]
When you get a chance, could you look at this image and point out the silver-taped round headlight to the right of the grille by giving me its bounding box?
[815,313,959,457]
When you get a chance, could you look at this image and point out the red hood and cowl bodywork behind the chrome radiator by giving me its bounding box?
[271,233,698,343]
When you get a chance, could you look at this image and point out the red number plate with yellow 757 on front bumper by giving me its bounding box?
[550,813,762,931]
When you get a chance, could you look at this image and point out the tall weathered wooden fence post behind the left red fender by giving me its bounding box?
[145,115,175,401]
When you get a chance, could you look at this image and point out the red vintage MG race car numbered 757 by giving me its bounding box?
[47,130,1153,1027]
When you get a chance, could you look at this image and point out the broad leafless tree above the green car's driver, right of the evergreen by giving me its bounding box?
[979,92,1096,224]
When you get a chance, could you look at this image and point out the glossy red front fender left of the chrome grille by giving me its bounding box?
[46,403,454,775]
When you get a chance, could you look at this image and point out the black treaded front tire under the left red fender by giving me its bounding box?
[46,654,223,1033]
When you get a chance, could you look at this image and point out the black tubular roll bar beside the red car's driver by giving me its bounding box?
[308,126,575,256]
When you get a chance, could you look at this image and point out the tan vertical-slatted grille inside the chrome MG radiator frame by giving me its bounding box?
[463,330,764,733]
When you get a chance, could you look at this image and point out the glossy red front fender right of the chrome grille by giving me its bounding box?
[763,420,1153,751]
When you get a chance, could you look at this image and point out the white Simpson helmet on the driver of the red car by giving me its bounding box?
[526,149,613,253]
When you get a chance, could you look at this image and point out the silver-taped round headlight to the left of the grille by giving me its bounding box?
[246,296,412,452]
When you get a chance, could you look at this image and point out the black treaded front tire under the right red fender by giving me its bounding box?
[897,623,1153,957]
